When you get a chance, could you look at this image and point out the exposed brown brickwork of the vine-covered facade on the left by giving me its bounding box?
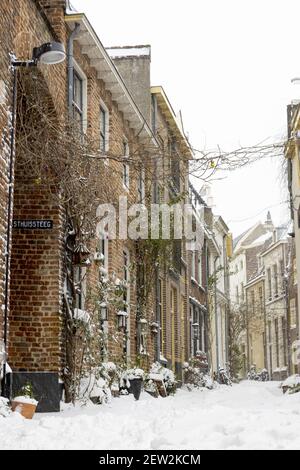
[0,0,200,410]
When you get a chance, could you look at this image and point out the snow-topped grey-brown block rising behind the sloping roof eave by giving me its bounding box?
[106,45,151,126]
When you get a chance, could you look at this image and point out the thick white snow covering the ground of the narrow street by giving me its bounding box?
[0,381,300,450]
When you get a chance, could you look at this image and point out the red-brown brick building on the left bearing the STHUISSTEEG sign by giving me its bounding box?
[0,0,202,411]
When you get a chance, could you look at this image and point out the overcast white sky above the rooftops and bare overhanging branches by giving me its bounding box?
[72,0,300,236]
